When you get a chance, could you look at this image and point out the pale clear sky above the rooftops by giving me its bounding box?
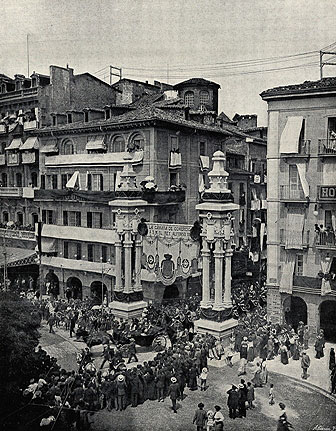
[0,0,336,125]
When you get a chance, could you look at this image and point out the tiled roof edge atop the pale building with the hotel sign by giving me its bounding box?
[260,77,336,99]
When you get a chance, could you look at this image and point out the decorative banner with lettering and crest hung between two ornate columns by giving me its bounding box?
[142,223,199,286]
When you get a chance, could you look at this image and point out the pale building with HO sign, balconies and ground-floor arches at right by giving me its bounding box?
[261,78,336,339]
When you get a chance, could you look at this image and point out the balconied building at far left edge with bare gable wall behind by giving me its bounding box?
[0,66,117,284]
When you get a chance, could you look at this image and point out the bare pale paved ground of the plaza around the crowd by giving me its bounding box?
[41,326,336,431]
